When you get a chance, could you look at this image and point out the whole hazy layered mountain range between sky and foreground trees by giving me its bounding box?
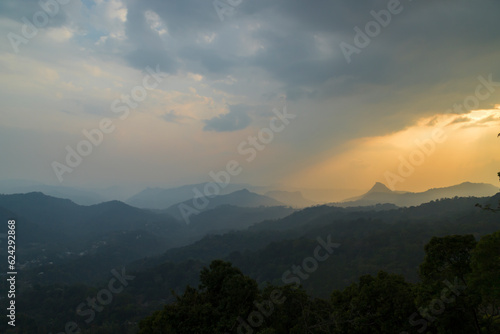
[0,179,500,333]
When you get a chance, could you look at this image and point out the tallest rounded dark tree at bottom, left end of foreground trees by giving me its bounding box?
[139,260,258,334]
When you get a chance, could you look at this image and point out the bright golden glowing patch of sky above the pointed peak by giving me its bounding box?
[285,109,500,191]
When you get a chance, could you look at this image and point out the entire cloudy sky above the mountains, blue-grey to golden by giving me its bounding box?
[0,0,500,196]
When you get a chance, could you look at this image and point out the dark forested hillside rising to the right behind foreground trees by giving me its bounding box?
[0,195,500,333]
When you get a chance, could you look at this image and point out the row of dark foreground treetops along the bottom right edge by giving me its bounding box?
[139,232,500,334]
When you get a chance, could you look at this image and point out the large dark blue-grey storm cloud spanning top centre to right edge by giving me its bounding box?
[118,0,500,106]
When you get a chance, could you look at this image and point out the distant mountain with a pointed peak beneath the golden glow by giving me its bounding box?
[336,182,499,206]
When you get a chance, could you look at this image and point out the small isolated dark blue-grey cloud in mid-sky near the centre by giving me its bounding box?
[203,104,252,132]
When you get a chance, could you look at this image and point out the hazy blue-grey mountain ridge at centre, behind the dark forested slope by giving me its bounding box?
[166,189,285,219]
